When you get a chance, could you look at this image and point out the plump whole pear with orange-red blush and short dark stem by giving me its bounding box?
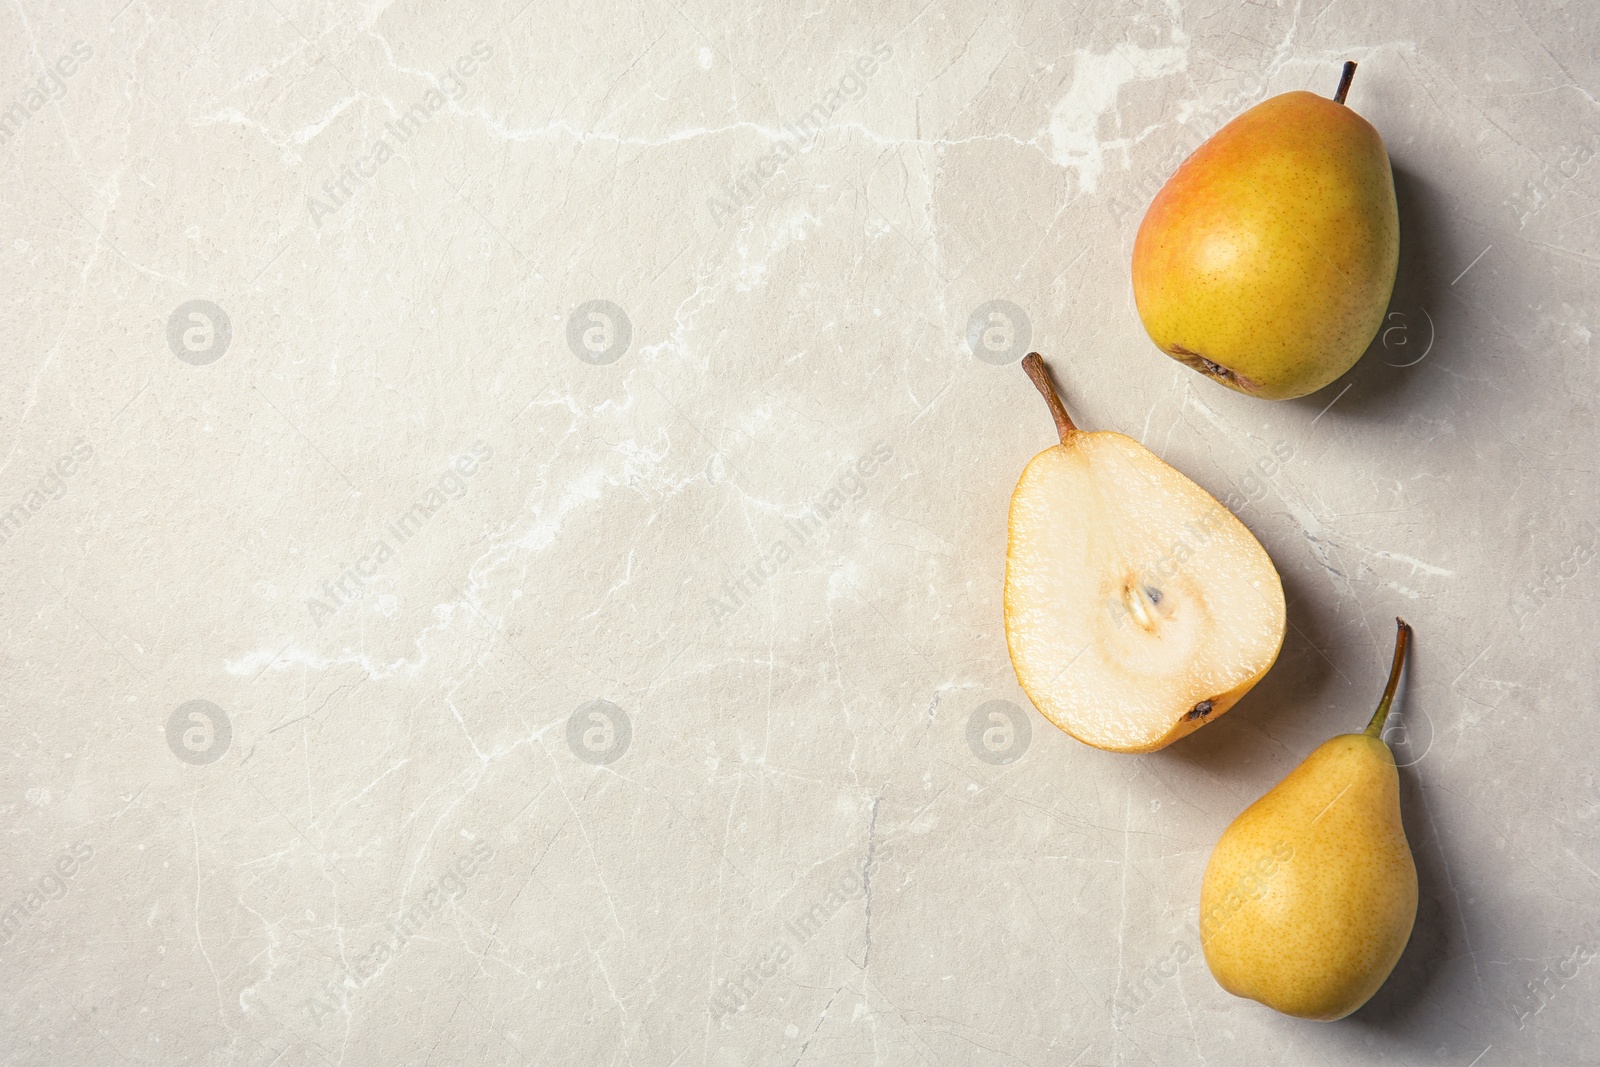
[1133,62,1400,400]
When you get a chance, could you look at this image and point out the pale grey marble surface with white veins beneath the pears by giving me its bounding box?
[0,0,1600,1067]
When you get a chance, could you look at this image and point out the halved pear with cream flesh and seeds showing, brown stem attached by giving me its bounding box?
[1005,352,1285,752]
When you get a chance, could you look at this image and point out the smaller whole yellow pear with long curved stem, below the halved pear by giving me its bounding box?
[1200,619,1416,1021]
